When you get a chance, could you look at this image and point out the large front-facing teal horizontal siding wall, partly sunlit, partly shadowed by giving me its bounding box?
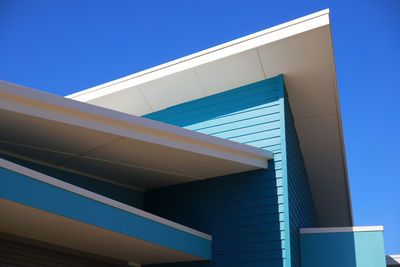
[145,76,285,267]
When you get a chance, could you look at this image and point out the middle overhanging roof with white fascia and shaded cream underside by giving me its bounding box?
[0,82,273,189]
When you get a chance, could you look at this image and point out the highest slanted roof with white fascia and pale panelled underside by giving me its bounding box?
[67,10,353,226]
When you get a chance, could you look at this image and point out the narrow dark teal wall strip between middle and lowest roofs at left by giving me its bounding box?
[0,153,144,209]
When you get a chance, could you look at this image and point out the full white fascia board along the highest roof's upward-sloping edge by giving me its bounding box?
[66,9,330,102]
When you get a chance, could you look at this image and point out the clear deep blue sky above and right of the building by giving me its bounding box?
[0,0,400,254]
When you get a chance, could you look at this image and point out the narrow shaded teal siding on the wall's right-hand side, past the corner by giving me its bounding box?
[285,94,317,267]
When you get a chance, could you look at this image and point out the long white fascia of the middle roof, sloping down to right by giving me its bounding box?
[0,81,273,168]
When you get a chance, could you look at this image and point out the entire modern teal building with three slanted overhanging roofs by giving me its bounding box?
[0,10,395,267]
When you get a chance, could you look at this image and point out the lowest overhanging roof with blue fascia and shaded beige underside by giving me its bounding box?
[0,159,212,264]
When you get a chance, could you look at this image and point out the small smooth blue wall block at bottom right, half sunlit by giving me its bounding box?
[300,231,386,267]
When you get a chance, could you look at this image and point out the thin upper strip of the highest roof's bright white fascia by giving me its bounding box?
[66,8,329,99]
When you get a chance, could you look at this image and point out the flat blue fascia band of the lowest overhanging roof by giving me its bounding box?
[0,168,211,259]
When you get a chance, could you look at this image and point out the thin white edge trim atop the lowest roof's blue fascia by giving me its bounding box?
[0,158,212,241]
